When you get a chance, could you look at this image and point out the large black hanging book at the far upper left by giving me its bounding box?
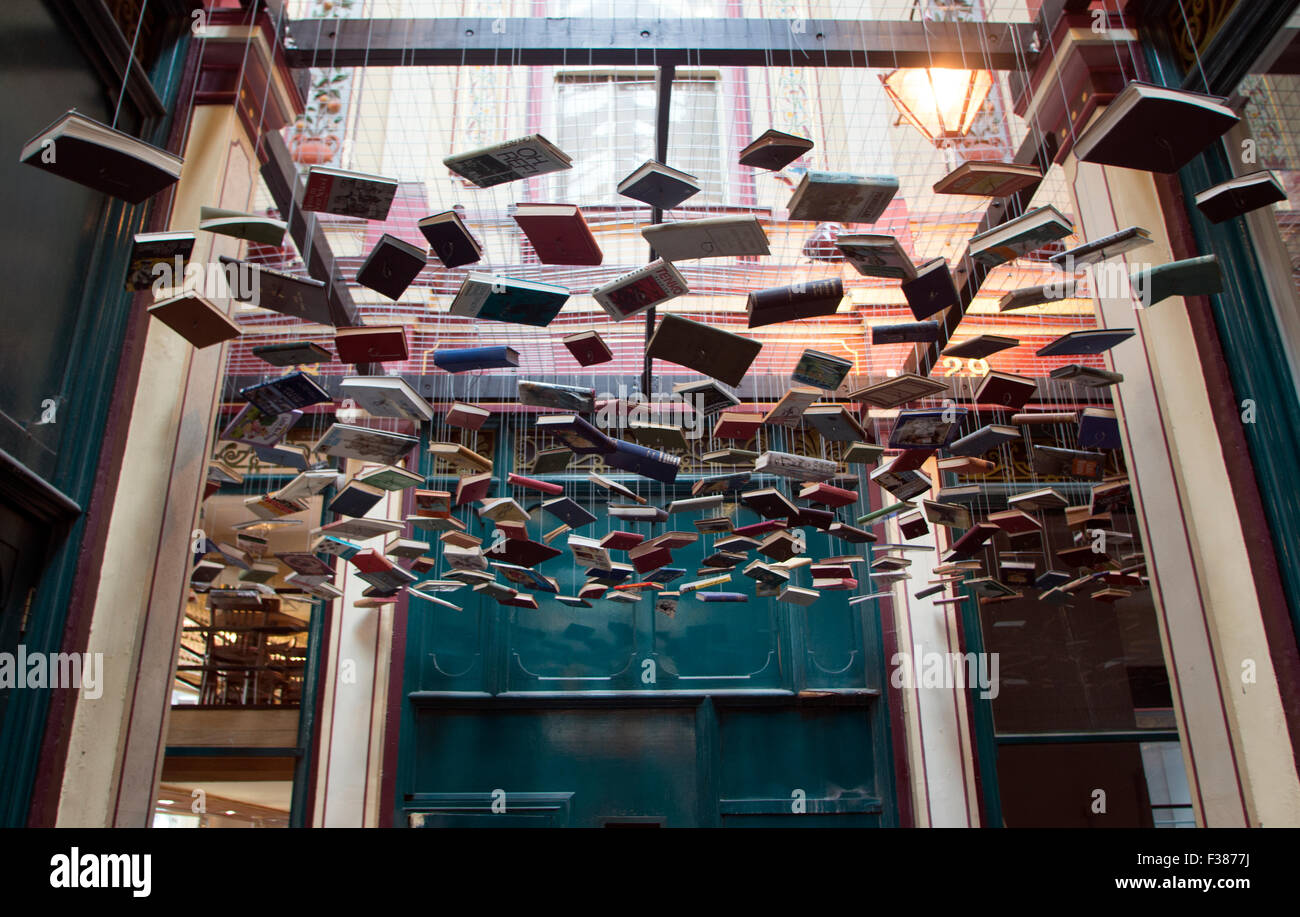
[18,111,182,204]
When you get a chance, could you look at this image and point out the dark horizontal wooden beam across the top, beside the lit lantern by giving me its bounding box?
[286,17,1034,70]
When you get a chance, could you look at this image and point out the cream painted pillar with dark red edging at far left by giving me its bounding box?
[57,105,256,826]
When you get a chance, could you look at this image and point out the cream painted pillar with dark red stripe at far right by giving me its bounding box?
[1066,153,1300,827]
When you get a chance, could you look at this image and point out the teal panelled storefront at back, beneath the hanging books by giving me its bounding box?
[394,426,898,827]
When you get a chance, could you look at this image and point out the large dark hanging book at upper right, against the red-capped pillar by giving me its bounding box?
[1074,81,1240,173]
